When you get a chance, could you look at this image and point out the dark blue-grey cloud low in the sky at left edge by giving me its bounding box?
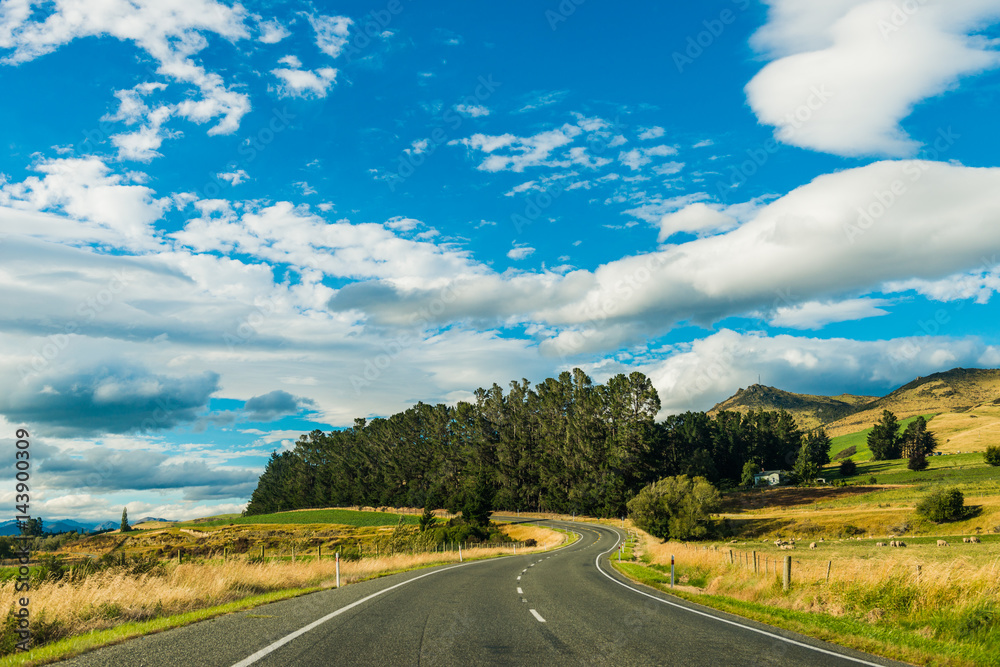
[0,363,219,435]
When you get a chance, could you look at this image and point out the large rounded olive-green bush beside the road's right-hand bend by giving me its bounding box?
[628,475,720,540]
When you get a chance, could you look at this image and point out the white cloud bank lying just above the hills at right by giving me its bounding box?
[624,329,996,414]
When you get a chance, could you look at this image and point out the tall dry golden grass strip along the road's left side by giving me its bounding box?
[0,526,563,643]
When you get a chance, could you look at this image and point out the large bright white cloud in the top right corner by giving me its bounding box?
[746,0,1000,156]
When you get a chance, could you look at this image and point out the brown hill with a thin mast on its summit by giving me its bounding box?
[708,384,877,430]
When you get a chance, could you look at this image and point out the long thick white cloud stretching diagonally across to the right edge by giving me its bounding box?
[331,161,1000,355]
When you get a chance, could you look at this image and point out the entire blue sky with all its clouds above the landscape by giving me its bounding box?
[0,0,1000,520]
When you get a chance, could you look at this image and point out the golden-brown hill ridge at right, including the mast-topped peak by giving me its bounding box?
[708,368,1000,437]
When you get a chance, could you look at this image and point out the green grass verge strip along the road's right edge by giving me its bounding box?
[612,561,1000,666]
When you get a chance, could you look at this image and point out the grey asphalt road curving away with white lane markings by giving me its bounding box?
[59,522,901,667]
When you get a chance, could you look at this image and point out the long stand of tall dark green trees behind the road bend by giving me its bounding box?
[246,369,829,517]
